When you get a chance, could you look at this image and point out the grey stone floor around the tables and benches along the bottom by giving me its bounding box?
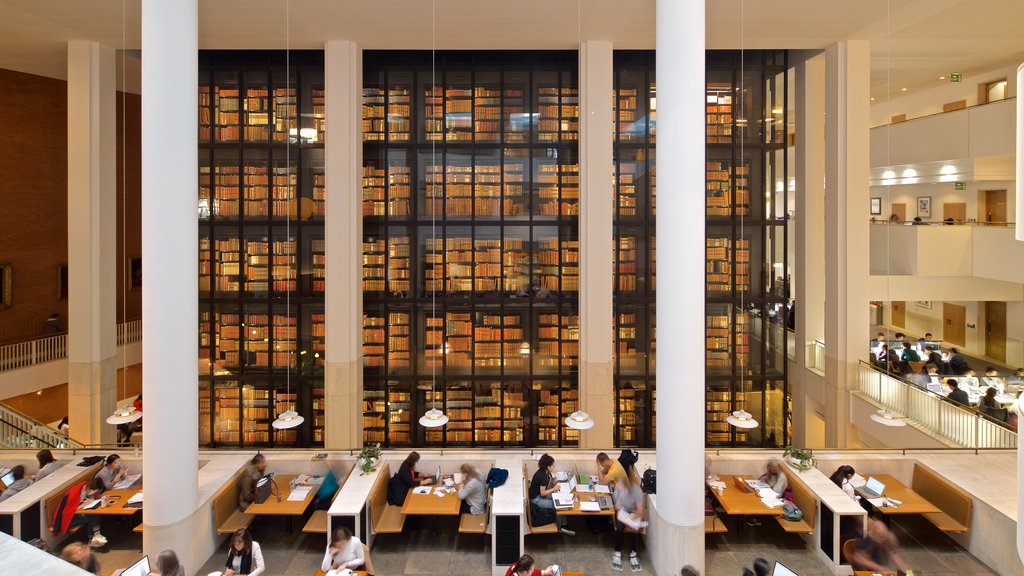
[77,510,995,576]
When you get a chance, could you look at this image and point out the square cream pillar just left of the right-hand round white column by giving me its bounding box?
[580,40,615,449]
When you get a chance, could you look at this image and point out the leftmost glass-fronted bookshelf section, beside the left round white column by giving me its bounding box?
[198,50,327,447]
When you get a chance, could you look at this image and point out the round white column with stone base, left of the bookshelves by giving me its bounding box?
[142,0,198,570]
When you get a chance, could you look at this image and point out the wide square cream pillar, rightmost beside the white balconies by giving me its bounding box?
[824,40,871,448]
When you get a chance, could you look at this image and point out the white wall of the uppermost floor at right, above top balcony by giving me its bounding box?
[871,66,1017,126]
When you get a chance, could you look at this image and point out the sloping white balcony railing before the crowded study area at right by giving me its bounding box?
[859,362,1017,448]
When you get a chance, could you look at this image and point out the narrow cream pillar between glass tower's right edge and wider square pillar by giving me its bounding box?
[790,55,825,447]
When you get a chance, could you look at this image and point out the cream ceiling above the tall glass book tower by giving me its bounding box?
[0,0,1024,98]
